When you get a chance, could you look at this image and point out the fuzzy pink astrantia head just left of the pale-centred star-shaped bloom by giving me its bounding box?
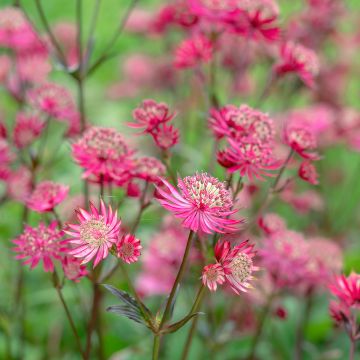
[13,222,67,272]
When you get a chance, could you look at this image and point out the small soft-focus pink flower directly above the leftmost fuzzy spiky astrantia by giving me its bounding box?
[26,181,69,213]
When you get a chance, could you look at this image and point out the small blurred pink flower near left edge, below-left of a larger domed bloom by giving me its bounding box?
[14,112,45,149]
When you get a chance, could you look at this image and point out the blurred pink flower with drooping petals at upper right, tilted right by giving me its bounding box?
[275,41,320,87]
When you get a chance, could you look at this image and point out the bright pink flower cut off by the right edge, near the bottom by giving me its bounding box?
[329,272,360,308]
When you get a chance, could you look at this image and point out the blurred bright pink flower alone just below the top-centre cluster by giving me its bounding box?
[174,34,213,69]
